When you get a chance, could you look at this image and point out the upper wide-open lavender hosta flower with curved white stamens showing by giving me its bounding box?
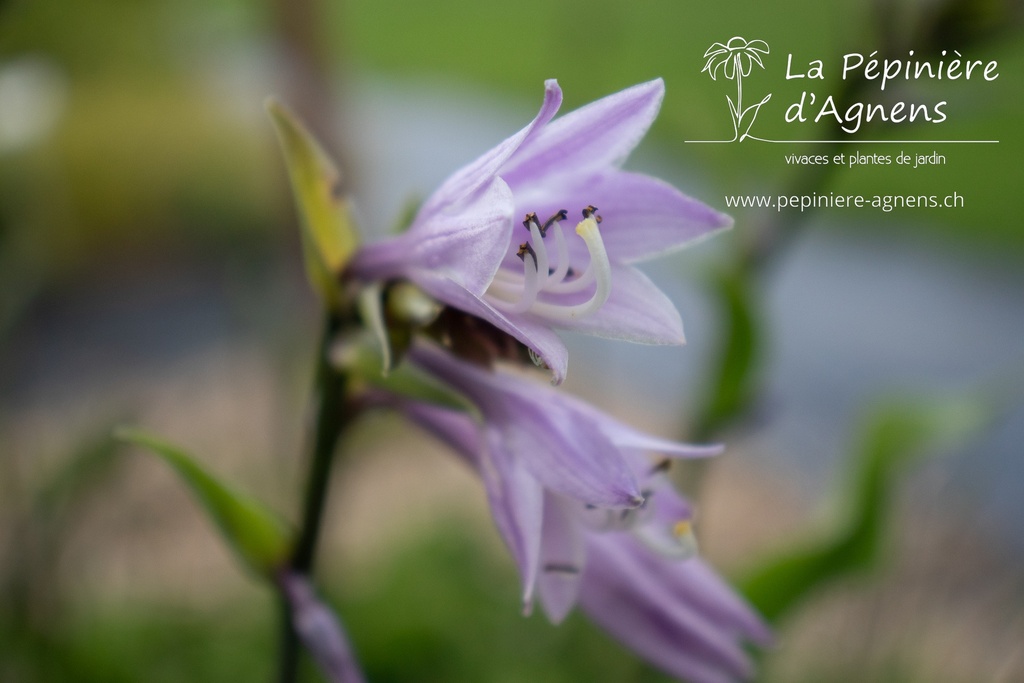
[351,80,731,383]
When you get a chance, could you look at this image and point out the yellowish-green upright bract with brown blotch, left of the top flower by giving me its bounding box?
[266,98,359,307]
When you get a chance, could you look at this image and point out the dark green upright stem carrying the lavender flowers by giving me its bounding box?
[278,312,355,683]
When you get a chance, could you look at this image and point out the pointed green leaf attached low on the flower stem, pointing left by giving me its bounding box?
[115,428,293,580]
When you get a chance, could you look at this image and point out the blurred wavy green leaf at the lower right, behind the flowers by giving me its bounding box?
[739,395,997,622]
